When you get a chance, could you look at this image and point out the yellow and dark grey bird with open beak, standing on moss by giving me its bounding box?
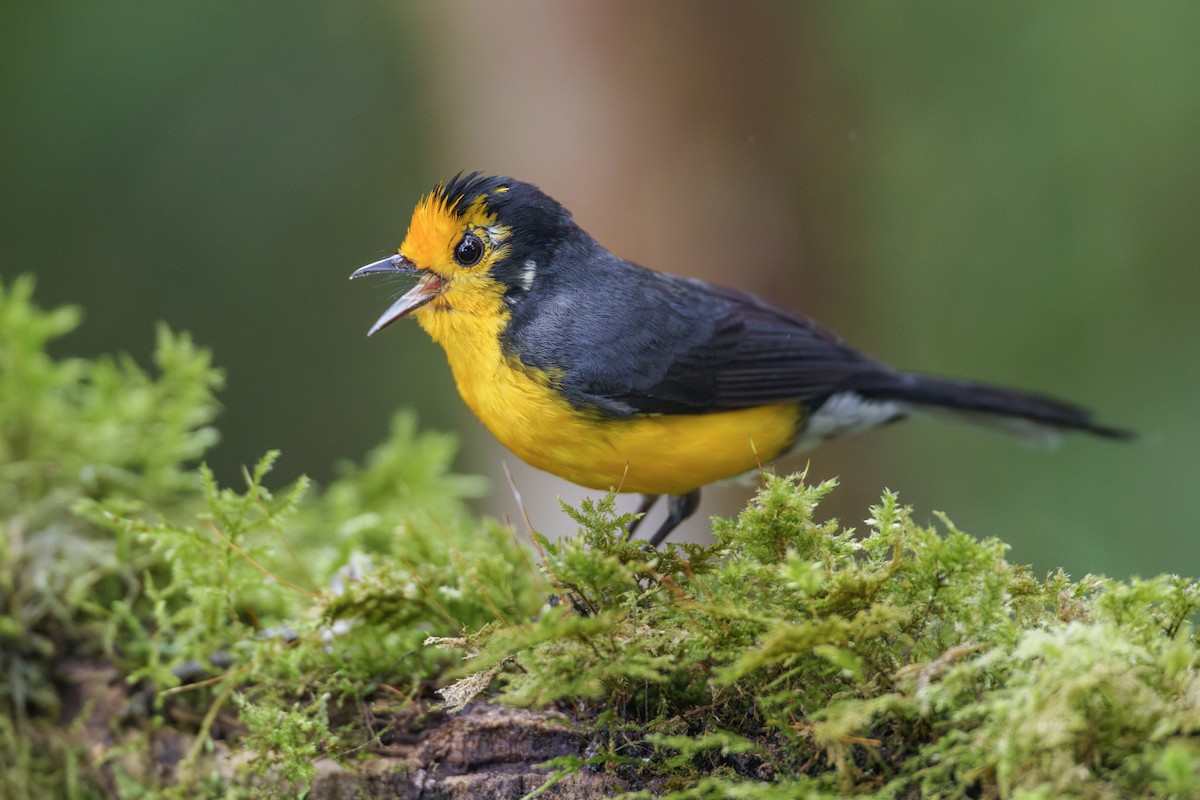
[350,172,1129,547]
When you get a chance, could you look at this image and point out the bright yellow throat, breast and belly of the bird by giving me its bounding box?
[418,302,800,494]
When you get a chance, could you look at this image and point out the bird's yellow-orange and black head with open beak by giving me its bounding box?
[350,173,582,336]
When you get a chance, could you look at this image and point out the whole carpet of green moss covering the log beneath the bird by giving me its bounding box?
[0,272,1200,799]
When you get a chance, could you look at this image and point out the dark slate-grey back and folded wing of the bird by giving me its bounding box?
[506,253,894,416]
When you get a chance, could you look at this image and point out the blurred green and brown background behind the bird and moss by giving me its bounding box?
[0,0,1200,577]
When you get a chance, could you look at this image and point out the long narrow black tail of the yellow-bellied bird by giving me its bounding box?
[854,372,1133,439]
